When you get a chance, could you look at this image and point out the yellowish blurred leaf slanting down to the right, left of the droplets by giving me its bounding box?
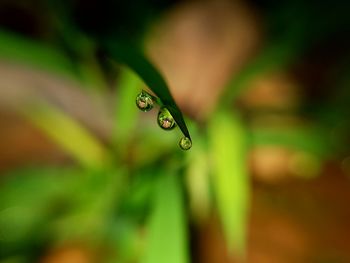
[22,105,110,168]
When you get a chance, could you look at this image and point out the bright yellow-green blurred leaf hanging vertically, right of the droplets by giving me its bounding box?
[209,112,249,257]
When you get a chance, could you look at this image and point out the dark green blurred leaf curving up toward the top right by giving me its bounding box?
[223,1,315,105]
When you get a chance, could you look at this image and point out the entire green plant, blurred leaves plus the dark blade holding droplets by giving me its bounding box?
[0,1,349,263]
